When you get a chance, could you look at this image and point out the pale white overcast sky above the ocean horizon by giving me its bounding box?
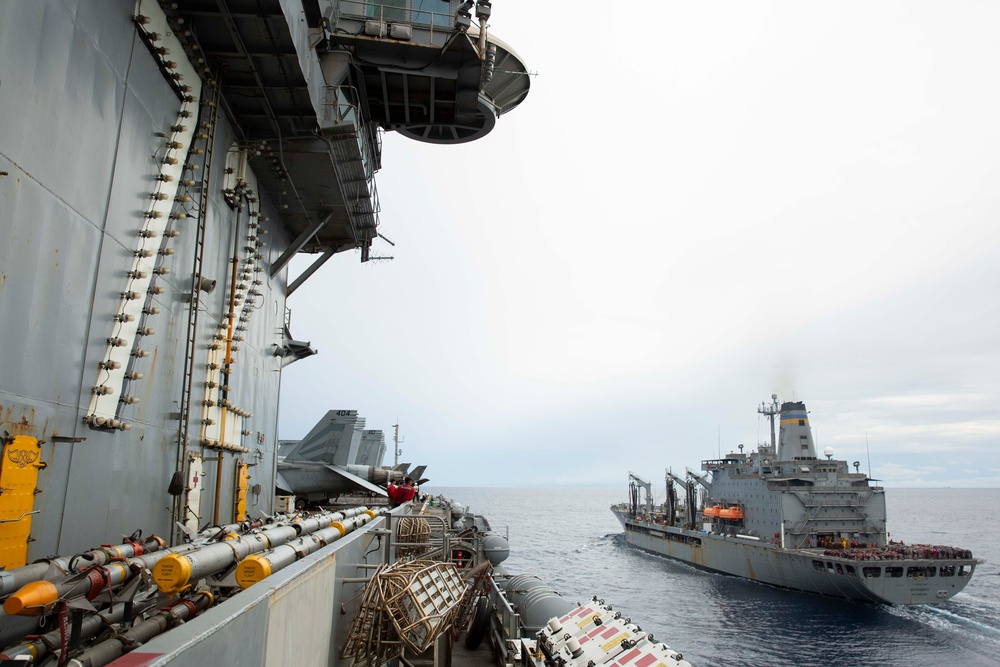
[281,0,1000,489]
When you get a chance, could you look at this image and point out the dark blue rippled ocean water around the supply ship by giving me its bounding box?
[436,484,1000,667]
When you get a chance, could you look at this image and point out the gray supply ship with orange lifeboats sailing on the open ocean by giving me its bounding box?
[611,395,978,604]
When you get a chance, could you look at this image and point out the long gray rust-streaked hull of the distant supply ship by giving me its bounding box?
[612,509,972,604]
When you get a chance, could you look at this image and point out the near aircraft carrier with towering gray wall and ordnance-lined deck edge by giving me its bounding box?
[0,0,687,667]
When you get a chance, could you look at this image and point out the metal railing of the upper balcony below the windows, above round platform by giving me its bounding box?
[331,0,455,45]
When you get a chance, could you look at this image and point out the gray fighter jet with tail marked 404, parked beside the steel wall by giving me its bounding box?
[275,410,427,501]
